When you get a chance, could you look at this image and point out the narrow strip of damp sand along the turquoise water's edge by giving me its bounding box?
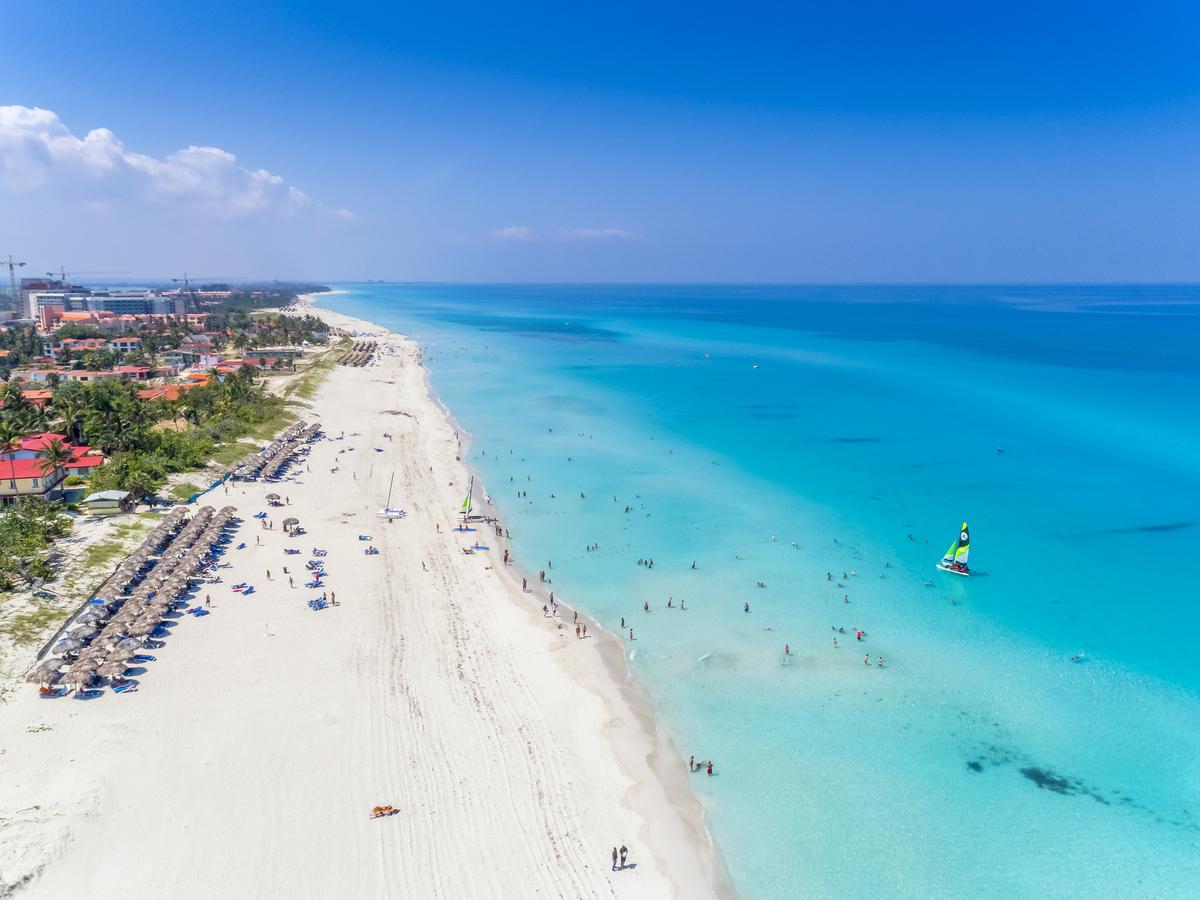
[298,290,736,900]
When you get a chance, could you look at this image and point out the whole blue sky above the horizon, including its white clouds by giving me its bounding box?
[0,0,1200,282]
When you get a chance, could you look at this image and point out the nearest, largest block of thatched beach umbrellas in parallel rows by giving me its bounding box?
[25,506,236,686]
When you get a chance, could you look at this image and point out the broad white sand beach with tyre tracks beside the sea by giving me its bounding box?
[0,304,728,899]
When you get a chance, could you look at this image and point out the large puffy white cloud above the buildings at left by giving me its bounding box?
[0,106,354,220]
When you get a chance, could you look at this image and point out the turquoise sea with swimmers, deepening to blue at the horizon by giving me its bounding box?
[320,284,1200,900]
